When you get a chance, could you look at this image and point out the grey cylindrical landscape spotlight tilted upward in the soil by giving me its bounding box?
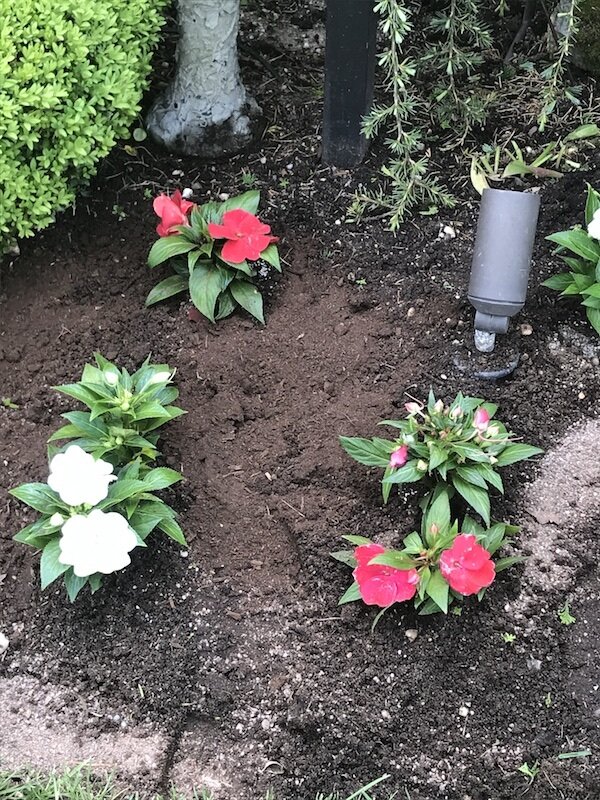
[468,189,540,353]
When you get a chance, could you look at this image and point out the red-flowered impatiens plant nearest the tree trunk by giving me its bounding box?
[146,191,281,323]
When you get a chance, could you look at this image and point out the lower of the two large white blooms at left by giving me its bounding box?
[58,508,138,578]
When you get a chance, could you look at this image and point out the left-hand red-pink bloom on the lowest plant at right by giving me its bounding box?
[352,544,419,608]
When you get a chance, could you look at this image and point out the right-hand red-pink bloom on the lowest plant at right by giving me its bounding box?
[440,533,496,595]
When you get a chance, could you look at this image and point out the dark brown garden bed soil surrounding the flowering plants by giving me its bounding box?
[0,3,600,800]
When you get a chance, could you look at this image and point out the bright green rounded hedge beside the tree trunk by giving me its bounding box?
[0,0,165,254]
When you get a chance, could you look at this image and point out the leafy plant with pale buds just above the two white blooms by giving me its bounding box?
[49,353,185,466]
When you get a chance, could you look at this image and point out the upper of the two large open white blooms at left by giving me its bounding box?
[48,444,117,506]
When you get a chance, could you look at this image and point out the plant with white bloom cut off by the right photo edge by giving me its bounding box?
[542,184,600,333]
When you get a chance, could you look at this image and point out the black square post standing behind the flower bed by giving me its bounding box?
[323,0,377,168]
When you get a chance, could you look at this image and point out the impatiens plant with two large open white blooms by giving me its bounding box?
[10,444,186,602]
